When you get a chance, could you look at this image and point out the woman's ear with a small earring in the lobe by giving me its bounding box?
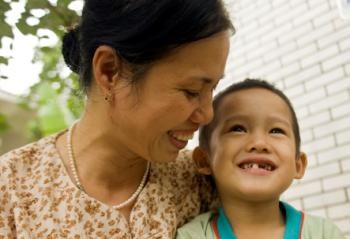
[92,45,121,100]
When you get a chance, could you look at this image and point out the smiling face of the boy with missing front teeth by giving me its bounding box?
[210,88,306,202]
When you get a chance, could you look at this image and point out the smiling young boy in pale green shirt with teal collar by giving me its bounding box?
[177,79,344,239]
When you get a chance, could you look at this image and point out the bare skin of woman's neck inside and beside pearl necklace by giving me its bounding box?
[57,115,147,212]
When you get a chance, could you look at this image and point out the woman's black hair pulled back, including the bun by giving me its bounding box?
[62,0,234,91]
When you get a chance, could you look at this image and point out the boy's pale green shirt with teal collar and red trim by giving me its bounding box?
[176,202,345,239]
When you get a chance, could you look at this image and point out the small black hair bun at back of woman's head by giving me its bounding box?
[62,26,80,74]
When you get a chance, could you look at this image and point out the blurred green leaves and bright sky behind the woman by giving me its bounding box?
[0,0,84,154]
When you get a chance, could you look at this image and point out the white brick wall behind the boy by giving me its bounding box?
[213,0,350,238]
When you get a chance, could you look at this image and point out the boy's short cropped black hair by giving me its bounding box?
[199,79,300,156]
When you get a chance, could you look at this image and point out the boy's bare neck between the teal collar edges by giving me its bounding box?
[223,200,285,239]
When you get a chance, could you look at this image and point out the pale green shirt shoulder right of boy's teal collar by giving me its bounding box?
[302,215,345,239]
